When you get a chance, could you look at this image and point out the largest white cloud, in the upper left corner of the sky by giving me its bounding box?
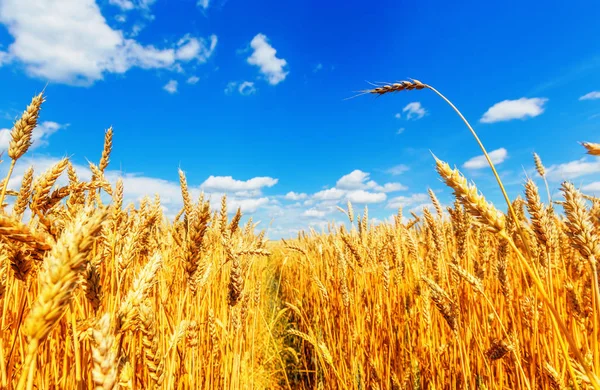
[0,0,217,85]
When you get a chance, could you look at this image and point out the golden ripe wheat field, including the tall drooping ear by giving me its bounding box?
[0,80,600,390]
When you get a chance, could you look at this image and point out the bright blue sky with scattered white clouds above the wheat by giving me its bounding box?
[0,0,600,238]
